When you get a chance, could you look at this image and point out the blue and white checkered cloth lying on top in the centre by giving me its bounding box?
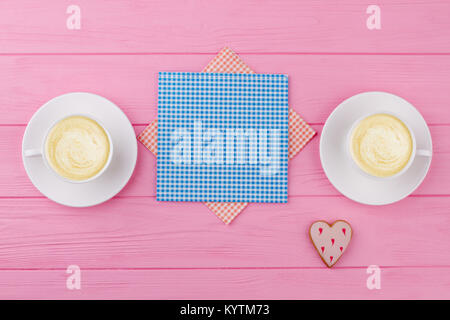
[157,72,289,202]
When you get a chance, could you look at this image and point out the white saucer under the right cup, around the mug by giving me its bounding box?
[320,92,433,205]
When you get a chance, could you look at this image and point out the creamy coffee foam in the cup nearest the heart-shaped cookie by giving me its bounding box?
[350,113,413,177]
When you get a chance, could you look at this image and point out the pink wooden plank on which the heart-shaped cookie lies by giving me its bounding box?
[0,197,450,269]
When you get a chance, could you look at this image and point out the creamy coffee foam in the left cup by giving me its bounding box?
[45,116,110,181]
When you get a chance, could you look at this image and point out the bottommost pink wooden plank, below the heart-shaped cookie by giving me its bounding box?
[0,267,450,299]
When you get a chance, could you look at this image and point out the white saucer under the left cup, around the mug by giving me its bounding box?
[22,92,137,207]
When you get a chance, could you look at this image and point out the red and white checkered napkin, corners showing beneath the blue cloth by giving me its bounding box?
[137,47,316,224]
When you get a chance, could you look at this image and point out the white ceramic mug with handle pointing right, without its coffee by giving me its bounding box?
[346,111,432,180]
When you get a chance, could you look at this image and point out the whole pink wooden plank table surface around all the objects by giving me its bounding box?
[0,0,450,299]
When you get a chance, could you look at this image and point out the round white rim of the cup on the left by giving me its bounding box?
[41,113,114,184]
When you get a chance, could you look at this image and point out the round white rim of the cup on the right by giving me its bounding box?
[346,110,417,180]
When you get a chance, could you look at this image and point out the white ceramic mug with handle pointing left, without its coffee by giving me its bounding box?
[23,114,114,183]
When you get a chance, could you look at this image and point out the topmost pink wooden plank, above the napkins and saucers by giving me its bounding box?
[0,0,450,53]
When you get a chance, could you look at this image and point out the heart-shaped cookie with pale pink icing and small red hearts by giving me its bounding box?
[309,220,352,268]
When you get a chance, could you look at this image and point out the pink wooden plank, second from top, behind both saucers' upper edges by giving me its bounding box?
[0,54,450,124]
